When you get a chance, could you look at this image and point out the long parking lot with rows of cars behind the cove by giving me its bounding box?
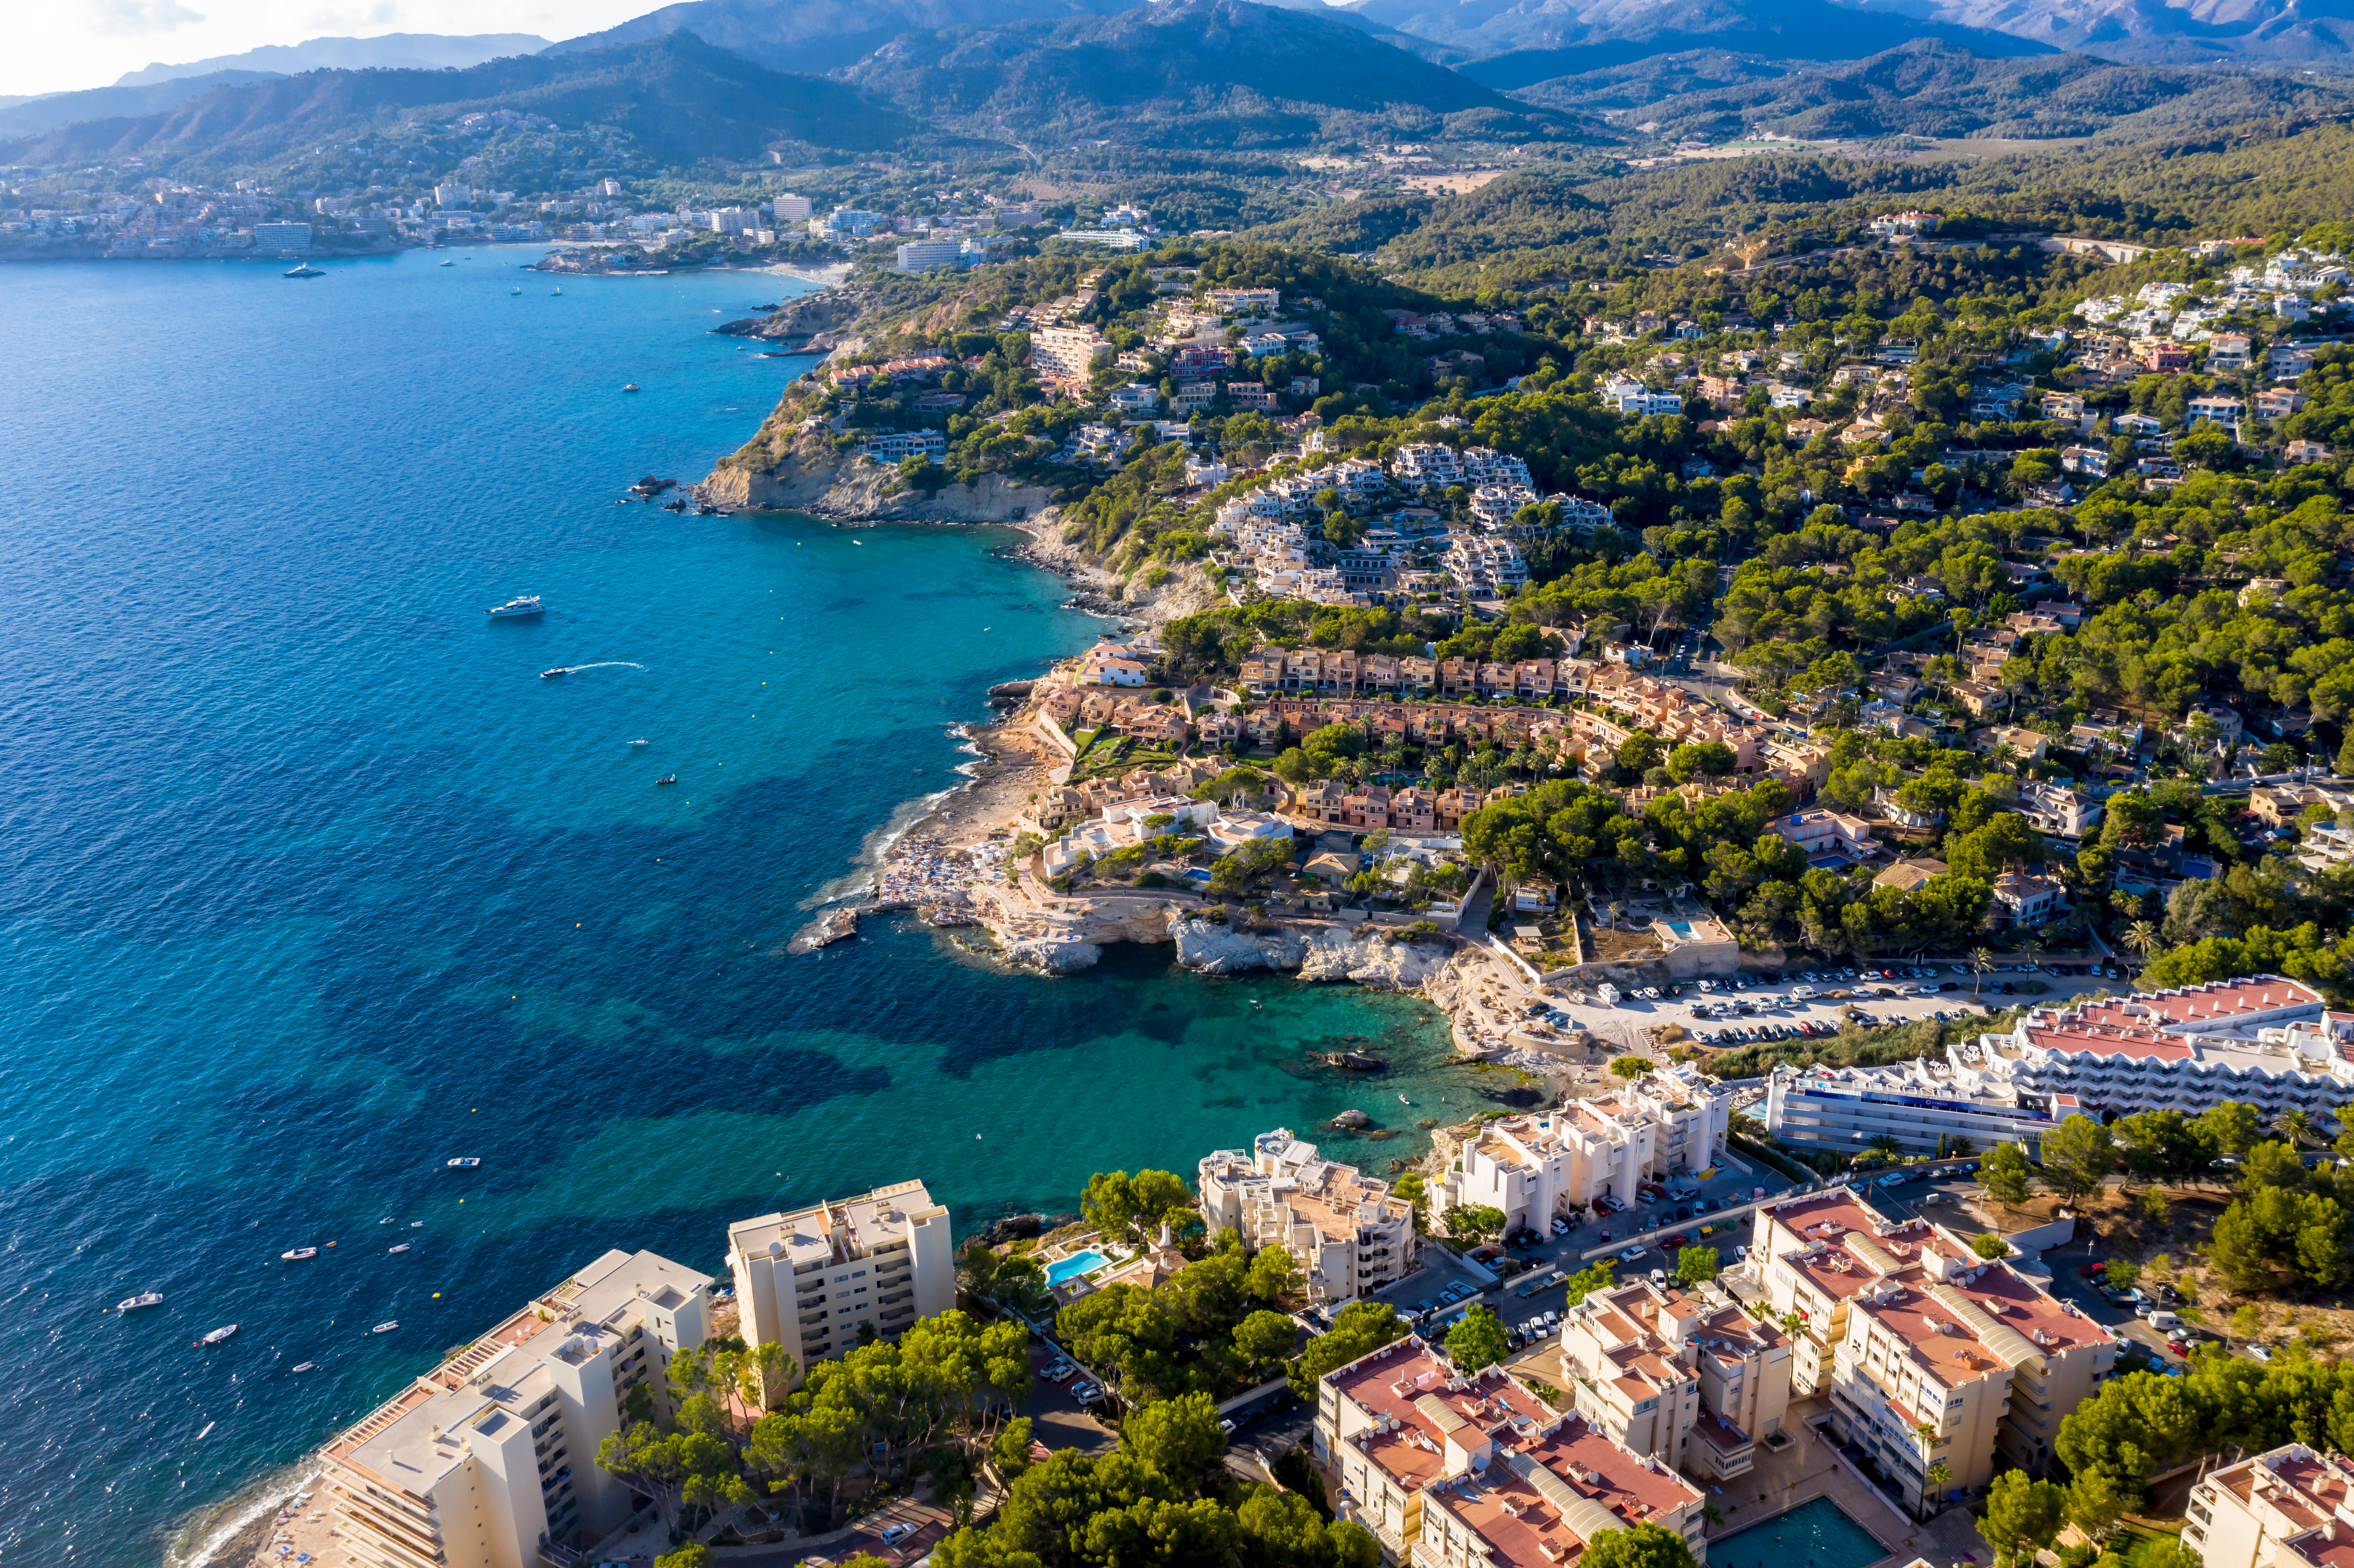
[1528,963,2133,1050]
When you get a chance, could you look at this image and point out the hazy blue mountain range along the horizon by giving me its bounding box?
[14,0,2354,165]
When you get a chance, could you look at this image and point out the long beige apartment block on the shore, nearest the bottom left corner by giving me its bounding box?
[320,1250,711,1568]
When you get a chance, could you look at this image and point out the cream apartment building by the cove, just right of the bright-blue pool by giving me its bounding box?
[1196,1128,1417,1304]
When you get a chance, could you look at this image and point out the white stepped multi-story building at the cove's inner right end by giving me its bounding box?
[1434,1064,1733,1231]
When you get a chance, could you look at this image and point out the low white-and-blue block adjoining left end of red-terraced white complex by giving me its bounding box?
[1766,1062,2076,1154]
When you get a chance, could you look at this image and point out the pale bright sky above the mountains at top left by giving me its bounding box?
[0,0,661,94]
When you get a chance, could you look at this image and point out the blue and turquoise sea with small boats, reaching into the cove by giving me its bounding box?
[0,249,1495,1566]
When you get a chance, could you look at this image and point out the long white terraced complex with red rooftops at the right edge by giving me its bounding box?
[1947,975,2354,1121]
